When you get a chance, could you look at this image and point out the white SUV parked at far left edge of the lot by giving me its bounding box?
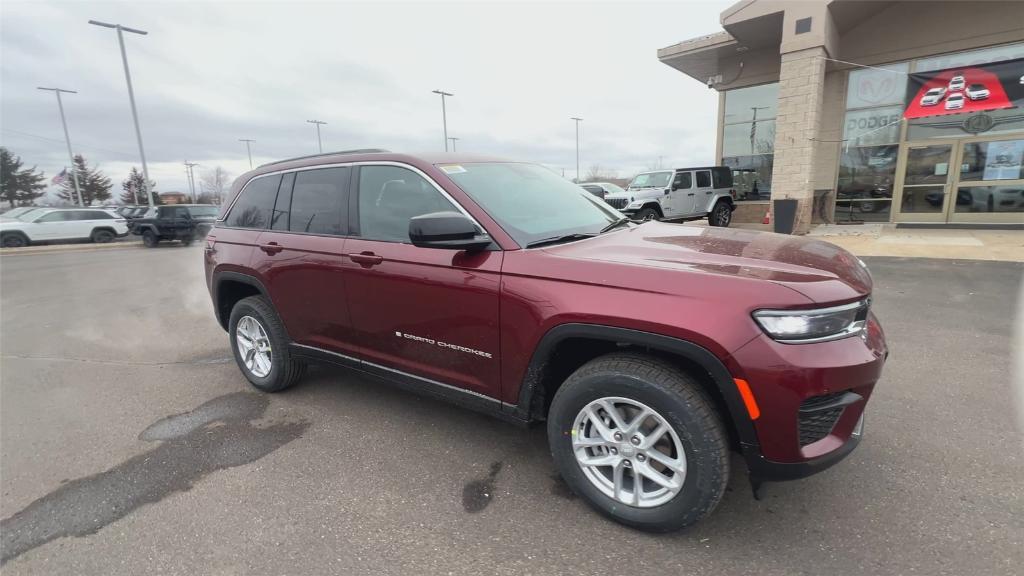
[0,208,128,248]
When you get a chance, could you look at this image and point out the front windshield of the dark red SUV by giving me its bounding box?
[439,162,623,246]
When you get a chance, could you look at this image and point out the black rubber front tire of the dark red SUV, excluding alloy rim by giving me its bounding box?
[548,353,729,532]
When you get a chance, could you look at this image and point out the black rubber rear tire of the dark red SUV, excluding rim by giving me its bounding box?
[227,296,305,393]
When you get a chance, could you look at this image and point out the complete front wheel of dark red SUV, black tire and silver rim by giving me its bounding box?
[548,354,729,532]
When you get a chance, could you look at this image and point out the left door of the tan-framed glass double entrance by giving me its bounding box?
[896,142,955,222]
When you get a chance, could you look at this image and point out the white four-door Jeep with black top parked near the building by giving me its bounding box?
[604,166,736,227]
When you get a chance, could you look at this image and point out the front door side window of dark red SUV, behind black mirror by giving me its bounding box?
[358,166,458,242]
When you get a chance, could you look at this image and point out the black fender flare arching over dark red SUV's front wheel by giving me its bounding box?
[513,323,759,448]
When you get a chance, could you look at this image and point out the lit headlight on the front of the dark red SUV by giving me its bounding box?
[754,298,870,344]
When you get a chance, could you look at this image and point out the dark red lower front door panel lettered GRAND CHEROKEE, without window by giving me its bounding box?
[344,238,502,398]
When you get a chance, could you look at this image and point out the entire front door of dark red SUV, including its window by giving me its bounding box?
[345,166,503,398]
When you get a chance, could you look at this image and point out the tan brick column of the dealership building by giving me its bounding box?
[771,46,827,234]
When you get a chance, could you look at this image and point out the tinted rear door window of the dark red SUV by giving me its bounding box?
[288,167,351,235]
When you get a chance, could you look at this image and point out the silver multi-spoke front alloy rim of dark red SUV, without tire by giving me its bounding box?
[571,397,686,508]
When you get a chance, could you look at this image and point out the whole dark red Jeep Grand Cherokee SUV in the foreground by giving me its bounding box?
[206,151,887,531]
